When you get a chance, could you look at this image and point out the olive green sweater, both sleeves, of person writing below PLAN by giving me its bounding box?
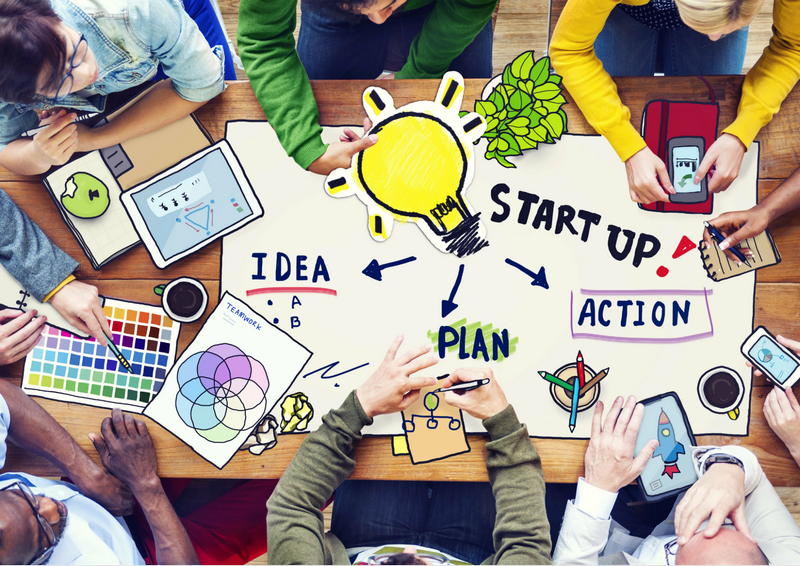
[267,391,551,564]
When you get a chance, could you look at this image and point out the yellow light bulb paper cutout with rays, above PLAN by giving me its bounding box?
[325,72,489,257]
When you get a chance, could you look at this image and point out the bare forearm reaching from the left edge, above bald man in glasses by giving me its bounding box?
[0,379,97,483]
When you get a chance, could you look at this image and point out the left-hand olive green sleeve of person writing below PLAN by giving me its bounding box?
[267,391,372,564]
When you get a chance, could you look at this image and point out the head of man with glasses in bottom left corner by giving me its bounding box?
[0,483,67,564]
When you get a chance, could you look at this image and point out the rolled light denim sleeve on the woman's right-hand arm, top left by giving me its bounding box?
[128,0,225,102]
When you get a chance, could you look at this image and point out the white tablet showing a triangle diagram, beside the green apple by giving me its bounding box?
[120,140,264,269]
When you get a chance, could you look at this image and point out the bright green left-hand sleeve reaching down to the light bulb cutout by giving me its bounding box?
[237,0,327,169]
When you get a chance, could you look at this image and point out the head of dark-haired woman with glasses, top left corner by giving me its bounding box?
[0,0,98,103]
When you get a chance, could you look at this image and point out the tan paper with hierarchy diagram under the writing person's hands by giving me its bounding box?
[400,385,469,464]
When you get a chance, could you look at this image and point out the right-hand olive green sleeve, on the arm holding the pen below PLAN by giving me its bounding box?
[483,405,552,564]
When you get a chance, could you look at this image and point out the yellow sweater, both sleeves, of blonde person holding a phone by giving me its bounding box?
[550,0,800,161]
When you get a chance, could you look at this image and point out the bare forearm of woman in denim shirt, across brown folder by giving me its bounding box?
[79,79,205,151]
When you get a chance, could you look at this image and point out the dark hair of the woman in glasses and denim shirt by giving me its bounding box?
[0,0,66,102]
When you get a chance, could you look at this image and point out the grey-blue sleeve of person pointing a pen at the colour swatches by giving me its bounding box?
[0,189,78,301]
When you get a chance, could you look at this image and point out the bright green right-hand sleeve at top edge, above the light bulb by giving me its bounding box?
[395,0,497,79]
